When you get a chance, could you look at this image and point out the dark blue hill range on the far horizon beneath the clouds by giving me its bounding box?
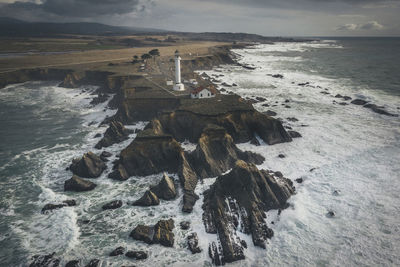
[0,17,164,37]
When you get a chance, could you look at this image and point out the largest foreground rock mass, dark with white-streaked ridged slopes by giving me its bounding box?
[203,161,295,265]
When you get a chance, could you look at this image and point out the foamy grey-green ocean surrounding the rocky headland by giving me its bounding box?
[0,38,400,266]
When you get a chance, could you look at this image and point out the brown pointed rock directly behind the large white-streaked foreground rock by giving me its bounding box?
[191,125,265,178]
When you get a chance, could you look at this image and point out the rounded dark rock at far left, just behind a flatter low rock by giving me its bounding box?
[69,152,106,178]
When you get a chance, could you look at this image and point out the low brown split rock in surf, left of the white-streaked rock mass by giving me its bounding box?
[130,219,175,247]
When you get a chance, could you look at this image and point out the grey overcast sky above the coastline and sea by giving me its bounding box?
[0,0,400,36]
